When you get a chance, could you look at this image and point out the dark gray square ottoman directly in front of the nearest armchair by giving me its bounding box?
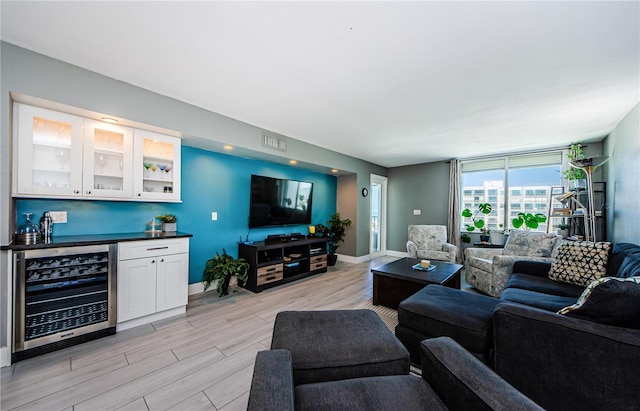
[271,310,410,385]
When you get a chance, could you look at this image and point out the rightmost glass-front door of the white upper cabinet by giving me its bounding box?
[133,130,181,201]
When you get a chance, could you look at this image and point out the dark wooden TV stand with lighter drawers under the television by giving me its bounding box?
[238,237,327,293]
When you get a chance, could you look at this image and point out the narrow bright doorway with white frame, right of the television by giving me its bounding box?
[369,174,387,258]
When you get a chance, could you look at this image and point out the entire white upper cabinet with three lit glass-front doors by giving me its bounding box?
[12,103,181,202]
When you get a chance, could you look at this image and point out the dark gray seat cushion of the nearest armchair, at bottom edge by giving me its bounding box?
[295,375,448,410]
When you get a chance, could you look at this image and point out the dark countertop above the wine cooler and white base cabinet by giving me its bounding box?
[1,231,193,251]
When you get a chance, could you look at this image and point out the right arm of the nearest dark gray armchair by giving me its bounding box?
[421,337,542,410]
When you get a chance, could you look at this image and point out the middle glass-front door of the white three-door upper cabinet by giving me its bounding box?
[83,119,133,198]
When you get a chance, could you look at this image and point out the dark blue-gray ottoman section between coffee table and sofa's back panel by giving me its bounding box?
[396,285,502,364]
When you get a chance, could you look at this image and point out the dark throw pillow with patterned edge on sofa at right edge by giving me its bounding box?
[558,277,640,329]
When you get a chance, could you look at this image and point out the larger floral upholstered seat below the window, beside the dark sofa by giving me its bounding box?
[464,231,562,297]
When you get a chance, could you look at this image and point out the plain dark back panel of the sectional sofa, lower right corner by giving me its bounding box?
[493,304,640,410]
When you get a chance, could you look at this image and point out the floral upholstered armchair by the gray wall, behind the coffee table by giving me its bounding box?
[407,225,458,263]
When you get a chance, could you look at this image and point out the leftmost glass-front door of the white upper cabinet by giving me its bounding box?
[13,103,83,197]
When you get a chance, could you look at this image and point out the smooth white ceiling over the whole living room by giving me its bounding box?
[0,1,640,167]
